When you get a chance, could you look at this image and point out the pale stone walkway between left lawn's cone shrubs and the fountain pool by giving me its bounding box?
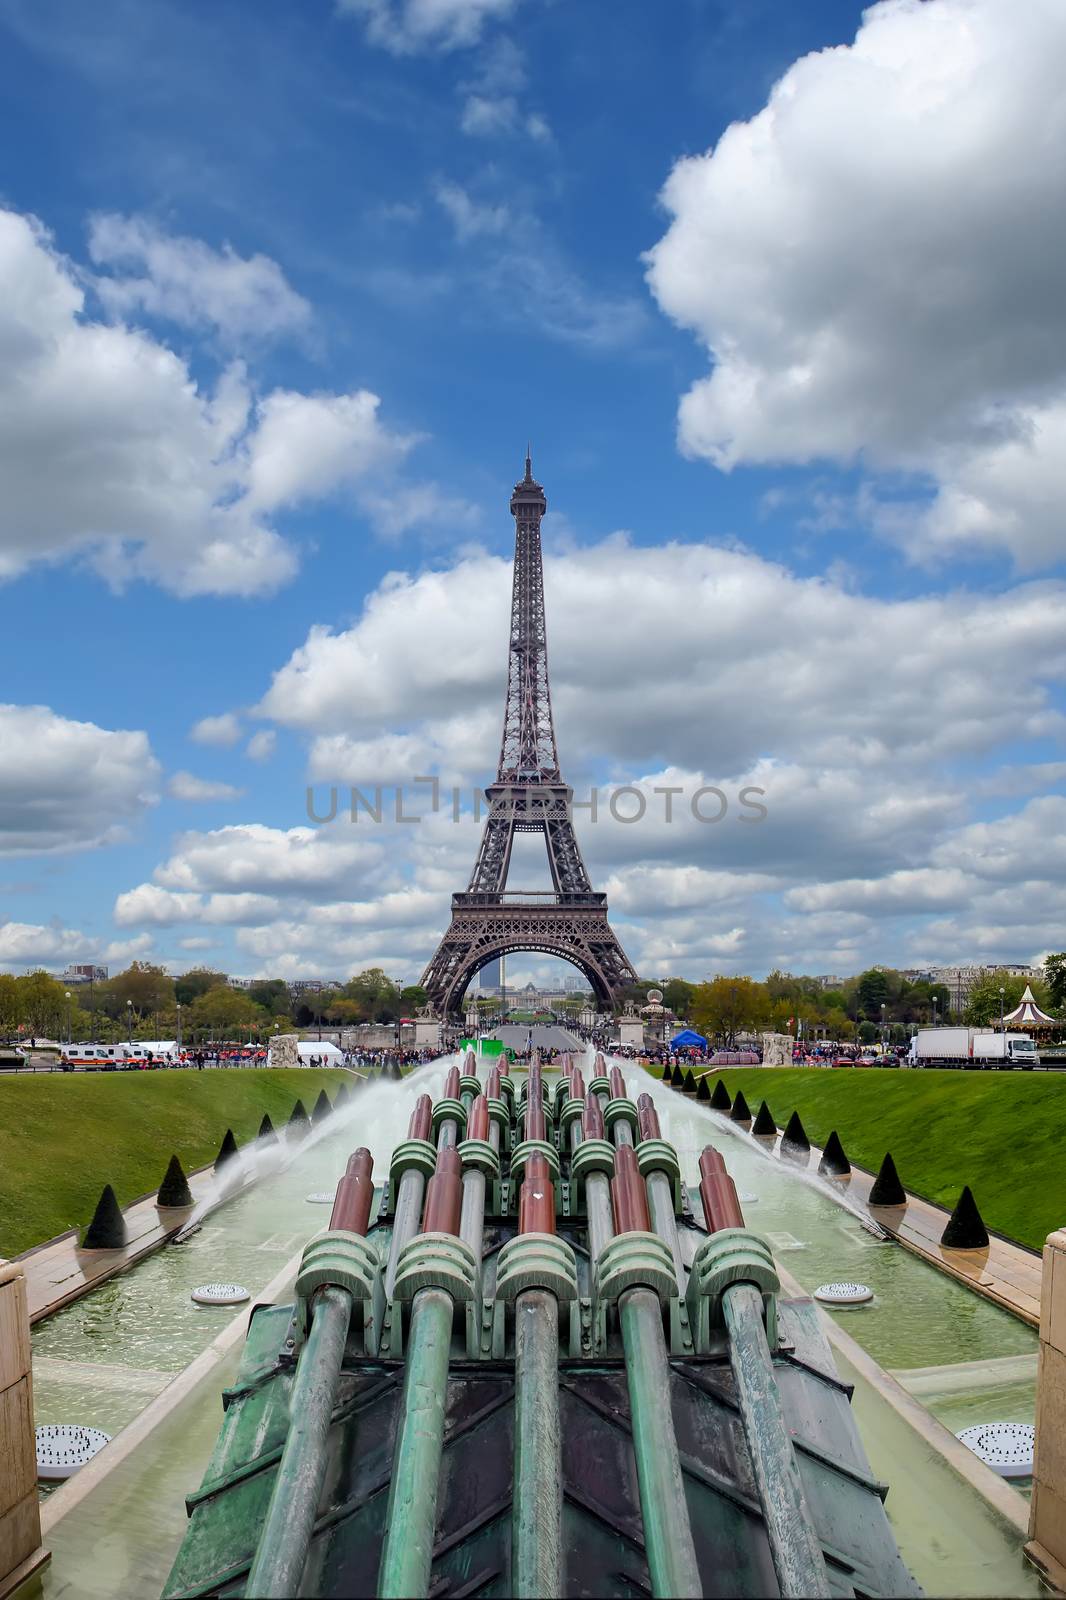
[18,1166,213,1325]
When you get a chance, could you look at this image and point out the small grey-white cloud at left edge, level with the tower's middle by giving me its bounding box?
[0,706,160,856]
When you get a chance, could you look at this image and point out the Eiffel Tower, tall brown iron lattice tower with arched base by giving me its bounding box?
[423,454,637,1016]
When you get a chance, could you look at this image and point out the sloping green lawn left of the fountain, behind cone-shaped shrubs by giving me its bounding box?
[0,1067,352,1256]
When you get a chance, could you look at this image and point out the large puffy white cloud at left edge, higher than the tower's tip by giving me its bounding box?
[0,210,438,597]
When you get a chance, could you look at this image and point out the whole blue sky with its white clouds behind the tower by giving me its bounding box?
[0,0,1066,979]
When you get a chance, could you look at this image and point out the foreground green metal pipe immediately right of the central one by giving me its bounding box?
[618,1288,703,1600]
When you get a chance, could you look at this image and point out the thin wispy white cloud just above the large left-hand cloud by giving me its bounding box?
[90,214,311,344]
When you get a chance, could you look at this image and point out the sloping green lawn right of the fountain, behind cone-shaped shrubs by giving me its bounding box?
[665,1067,1066,1250]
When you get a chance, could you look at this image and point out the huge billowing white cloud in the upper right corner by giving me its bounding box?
[648,0,1066,565]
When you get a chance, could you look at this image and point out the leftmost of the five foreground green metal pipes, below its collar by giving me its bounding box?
[245,1288,352,1600]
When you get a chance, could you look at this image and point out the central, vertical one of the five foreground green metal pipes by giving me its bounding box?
[511,1290,562,1600]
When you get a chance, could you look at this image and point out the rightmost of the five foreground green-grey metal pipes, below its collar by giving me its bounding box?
[722,1283,832,1600]
